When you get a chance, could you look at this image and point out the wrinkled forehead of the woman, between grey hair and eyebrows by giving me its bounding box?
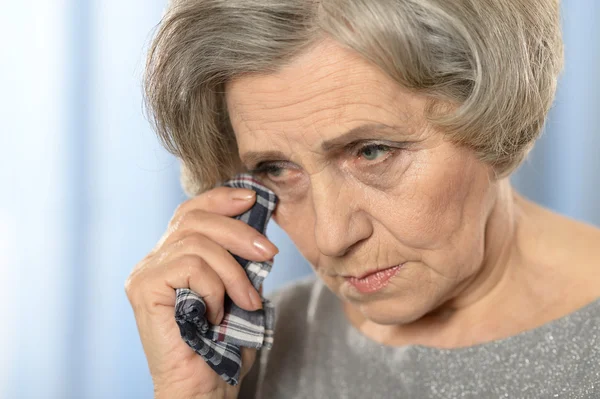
[226,38,425,159]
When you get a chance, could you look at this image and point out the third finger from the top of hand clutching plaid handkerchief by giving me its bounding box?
[161,233,262,311]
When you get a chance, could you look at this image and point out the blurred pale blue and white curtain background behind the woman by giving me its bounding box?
[0,0,600,399]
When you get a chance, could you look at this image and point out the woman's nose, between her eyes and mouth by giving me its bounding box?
[311,173,372,257]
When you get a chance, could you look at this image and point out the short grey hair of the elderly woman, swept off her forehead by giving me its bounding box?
[145,0,563,196]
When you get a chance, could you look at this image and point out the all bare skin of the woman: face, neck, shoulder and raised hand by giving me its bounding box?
[125,36,600,399]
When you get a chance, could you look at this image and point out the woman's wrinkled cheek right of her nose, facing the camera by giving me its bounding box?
[374,153,484,251]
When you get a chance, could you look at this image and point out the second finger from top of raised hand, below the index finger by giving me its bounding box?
[161,209,279,262]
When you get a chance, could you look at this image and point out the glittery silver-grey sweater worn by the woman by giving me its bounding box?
[239,277,600,399]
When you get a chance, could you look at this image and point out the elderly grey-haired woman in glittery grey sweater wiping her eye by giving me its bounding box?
[126,0,600,399]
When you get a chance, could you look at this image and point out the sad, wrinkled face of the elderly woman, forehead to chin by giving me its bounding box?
[226,40,495,324]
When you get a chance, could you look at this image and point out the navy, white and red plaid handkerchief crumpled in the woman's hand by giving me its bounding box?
[175,174,277,385]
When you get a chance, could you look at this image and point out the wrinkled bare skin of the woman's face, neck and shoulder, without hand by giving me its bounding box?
[226,40,598,347]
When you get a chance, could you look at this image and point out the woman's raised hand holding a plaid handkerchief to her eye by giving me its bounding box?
[125,187,278,399]
